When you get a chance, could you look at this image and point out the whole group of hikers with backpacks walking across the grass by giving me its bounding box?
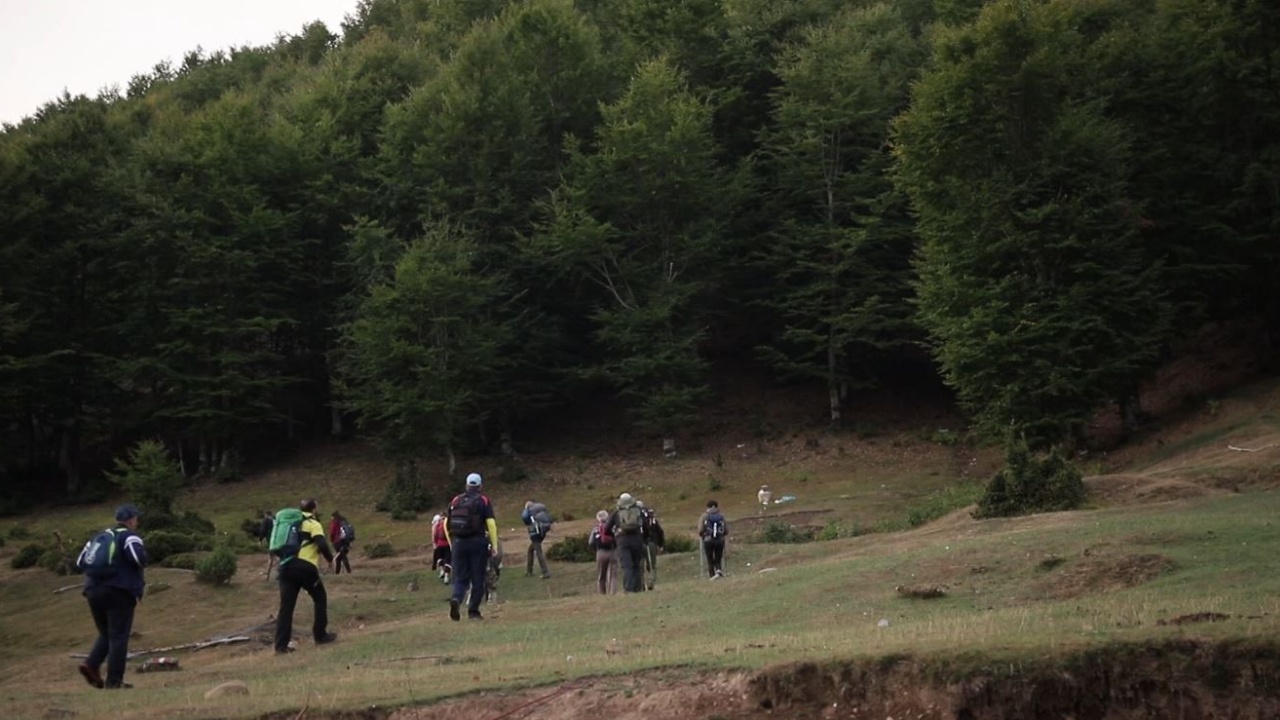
[76,473,728,689]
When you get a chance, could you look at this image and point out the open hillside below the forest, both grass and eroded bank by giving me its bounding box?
[0,371,1280,720]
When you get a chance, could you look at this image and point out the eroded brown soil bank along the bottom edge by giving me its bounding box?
[277,639,1280,720]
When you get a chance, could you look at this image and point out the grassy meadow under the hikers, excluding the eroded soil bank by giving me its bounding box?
[0,383,1280,719]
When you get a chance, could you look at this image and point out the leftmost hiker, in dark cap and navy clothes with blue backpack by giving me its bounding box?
[76,503,147,689]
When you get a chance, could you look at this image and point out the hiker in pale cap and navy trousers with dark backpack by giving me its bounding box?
[444,473,499,620]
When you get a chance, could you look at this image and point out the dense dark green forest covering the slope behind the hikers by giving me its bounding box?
[0,0,1280,504]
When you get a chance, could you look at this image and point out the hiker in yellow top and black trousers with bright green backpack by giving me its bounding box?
[271,497,338,653]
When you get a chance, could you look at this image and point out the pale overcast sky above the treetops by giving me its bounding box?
[0,0,358,123]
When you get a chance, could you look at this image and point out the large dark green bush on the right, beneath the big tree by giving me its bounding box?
[973,439,1084,518]
